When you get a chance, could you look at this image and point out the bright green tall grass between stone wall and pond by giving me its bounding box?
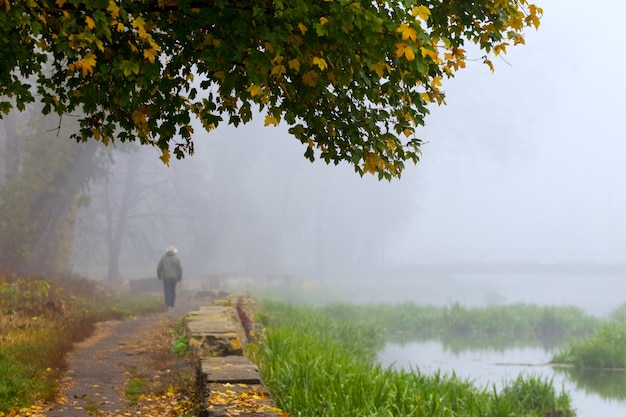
[256,302,574,417]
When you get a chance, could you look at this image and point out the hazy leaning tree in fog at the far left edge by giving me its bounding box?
[0,112,98,274]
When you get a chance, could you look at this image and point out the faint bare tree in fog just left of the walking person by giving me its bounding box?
[74,146,208,280]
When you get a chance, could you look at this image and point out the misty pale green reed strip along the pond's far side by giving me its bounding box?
[308,303,603,352]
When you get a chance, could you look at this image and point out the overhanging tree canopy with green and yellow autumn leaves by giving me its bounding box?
[0,0,543,178]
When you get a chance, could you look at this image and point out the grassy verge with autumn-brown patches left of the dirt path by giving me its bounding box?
[0,276,162,413]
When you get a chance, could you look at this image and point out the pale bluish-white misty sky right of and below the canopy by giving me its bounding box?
[160,0,626,270]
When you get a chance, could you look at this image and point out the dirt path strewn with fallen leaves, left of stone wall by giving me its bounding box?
[42,296,210,417]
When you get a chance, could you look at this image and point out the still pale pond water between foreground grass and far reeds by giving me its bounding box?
[378,341,626,417]
